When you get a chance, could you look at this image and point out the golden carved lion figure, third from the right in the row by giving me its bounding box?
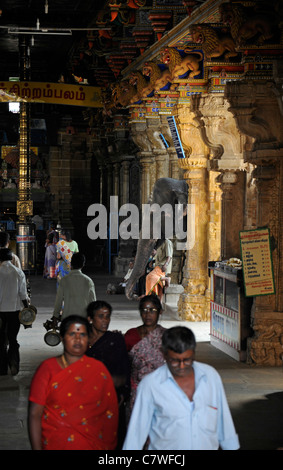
[161,47,203,81]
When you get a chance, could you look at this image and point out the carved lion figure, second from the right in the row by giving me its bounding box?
[190,24,238,60]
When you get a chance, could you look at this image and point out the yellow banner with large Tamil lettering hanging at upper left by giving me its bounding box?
[0,81,103,108]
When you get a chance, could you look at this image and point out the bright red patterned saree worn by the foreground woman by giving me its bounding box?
[29,356,118,450]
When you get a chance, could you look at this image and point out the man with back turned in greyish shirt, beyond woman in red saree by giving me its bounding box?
[52,253,96,321]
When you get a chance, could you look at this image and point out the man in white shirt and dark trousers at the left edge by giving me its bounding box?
[0,248,28,375]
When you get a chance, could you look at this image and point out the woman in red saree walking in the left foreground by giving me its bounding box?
[29,316,118,450]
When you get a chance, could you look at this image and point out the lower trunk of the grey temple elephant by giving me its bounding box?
[125,239,157,299]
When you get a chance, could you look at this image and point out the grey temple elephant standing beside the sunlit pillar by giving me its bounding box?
[125,178,188,299]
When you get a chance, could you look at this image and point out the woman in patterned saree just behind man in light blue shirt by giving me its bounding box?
[125,294,165,411]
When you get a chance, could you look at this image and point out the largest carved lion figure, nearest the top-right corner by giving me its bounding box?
[219,3,277,47]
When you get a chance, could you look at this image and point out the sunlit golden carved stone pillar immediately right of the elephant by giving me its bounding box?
[178,106,209,321]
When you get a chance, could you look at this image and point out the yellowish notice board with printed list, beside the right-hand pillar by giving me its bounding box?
[240,228,275,297]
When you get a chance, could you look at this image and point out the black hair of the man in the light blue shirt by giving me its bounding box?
[162,326,196,354]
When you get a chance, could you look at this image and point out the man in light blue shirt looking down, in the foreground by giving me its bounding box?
[123,326,239,450]
